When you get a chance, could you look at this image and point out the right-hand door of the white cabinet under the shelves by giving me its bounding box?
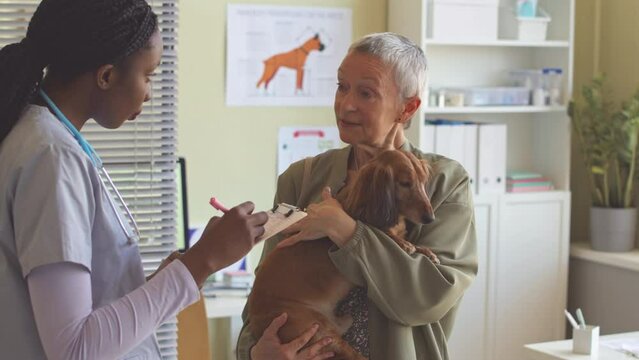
[489,192,570,359]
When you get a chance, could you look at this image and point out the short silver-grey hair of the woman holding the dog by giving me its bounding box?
[348,32,428,100]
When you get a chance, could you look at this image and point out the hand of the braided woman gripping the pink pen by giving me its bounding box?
[180,202,268,285]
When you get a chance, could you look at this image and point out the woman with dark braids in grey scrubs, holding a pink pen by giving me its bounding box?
[0,0,267,360]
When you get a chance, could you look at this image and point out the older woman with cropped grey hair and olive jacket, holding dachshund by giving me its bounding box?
[238,33,477,360]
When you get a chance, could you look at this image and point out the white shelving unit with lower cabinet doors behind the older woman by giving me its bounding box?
[388,0,575,360]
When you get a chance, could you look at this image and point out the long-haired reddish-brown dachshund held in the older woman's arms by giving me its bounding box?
[248,150,439,359]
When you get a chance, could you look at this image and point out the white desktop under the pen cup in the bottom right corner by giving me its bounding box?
[524,331,639,360]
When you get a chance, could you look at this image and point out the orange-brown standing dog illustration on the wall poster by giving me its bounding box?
[256,34,324,91]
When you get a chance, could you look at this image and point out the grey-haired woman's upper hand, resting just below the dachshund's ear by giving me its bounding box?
[277,187,357,247]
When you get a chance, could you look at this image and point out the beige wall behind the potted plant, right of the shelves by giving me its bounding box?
[571,0,639,241]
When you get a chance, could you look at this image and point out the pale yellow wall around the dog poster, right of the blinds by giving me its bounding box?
[178,0,387,266]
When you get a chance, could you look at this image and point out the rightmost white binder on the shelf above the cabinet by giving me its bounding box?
[477,124,507,194]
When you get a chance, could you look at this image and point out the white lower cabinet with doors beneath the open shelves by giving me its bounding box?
[448,191,570,360]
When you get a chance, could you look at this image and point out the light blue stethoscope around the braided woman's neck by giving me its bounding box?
[39,89,140,244]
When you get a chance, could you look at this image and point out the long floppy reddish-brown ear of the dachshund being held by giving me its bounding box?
[344,163,399,229]
